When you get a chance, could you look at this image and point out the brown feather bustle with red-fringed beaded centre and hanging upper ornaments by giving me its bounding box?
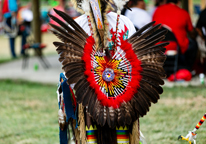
[50,0,168,144]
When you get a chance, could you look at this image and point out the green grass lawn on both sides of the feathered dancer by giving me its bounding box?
[0,80,206,144]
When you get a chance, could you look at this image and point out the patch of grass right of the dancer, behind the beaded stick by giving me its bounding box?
[140,87,206,144]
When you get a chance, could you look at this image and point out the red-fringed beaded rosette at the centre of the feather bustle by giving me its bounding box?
[82,36,142,108]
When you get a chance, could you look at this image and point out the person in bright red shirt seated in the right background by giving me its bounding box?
[152,0,197,71]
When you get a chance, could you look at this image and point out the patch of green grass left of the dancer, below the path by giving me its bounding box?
[0,81,59,144]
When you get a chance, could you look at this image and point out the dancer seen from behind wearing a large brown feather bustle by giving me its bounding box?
[50,0,168,144]
